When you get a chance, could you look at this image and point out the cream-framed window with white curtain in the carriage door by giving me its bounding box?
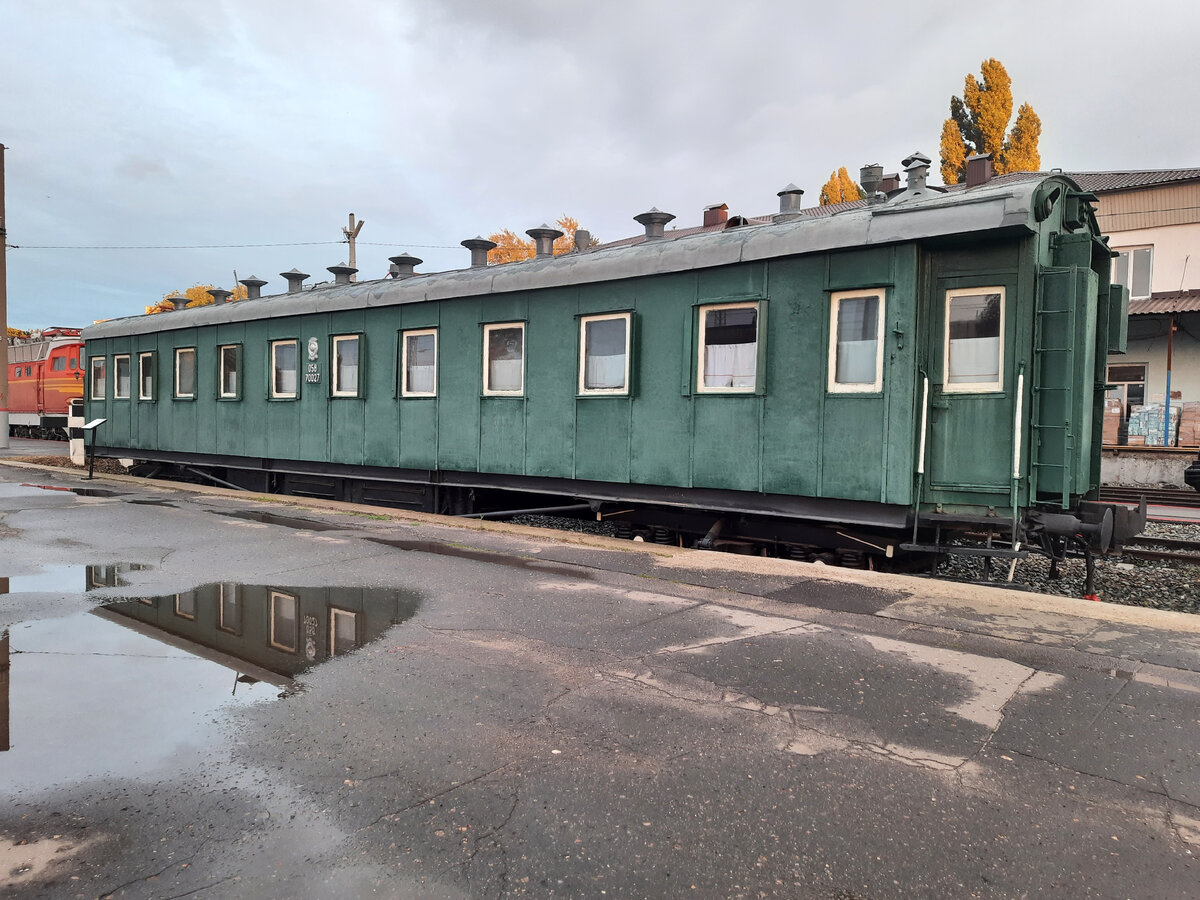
[943,288,1004,392]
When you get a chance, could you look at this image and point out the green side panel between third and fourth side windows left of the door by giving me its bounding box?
[524,286,578,478]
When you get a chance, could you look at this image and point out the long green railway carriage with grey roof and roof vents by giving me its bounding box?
[84,158,1126,556]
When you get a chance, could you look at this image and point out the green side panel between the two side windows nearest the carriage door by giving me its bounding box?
[762,256,829,497]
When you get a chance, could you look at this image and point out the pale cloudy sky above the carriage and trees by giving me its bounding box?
[0,0,1200,328]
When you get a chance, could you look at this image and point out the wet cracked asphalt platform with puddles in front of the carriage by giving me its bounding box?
[0,461,1200,900]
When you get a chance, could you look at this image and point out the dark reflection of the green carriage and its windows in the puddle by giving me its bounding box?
[88,565,420,689]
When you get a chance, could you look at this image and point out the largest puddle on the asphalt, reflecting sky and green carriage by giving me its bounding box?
[0,578,420,793]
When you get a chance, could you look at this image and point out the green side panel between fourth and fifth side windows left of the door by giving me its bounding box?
[436,298,484,472]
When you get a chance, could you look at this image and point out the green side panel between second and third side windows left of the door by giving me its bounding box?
[629,272,696,487]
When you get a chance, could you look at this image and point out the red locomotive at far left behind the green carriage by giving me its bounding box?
[8,328,84,440]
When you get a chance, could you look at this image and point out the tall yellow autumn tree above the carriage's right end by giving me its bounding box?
[941,59,1042,185]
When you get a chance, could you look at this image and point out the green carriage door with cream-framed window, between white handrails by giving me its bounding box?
[924,278,1015,505]
